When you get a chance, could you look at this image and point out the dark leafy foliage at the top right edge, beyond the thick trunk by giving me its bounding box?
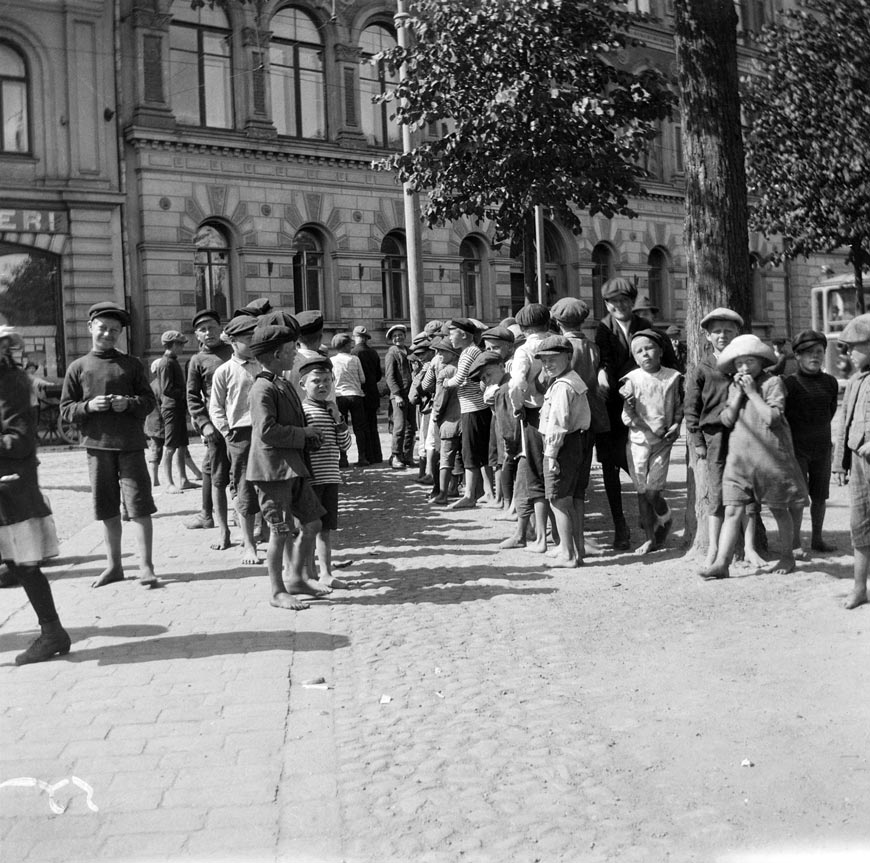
[744,0,870,295]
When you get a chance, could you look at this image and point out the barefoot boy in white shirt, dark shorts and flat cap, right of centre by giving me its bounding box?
[538,336,591,567]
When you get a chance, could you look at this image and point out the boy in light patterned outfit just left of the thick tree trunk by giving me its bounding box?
[619,330,683,554]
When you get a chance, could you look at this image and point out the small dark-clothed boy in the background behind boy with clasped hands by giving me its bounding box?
[154,330,194,494]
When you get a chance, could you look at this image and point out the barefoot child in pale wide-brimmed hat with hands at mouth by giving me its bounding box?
[701,335,807,579]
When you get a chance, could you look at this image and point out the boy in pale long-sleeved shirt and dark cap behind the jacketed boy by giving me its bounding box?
[208,314,261,566]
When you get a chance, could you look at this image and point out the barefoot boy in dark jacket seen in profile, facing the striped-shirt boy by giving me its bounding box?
[247,324,325,611]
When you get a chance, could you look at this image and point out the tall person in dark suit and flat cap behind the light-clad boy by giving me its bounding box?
[595,277,676,551]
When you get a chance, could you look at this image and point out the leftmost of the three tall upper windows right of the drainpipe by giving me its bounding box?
[169,0,233,129]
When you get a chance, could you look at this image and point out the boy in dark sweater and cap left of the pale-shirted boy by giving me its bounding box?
[184,309,233,548]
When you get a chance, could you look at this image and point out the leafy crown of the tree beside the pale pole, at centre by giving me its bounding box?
[379,0,673,245]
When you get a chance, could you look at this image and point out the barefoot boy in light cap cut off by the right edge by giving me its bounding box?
[834,315,870,609]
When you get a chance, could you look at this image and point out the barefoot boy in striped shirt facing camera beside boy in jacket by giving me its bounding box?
[299,357,351,588]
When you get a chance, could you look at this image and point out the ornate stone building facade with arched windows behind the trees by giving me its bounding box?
[0,0,844,372]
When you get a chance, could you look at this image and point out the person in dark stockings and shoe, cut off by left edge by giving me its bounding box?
[0,326,70,665]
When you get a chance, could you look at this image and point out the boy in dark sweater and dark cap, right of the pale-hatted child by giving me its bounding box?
[783,330,838,557]
